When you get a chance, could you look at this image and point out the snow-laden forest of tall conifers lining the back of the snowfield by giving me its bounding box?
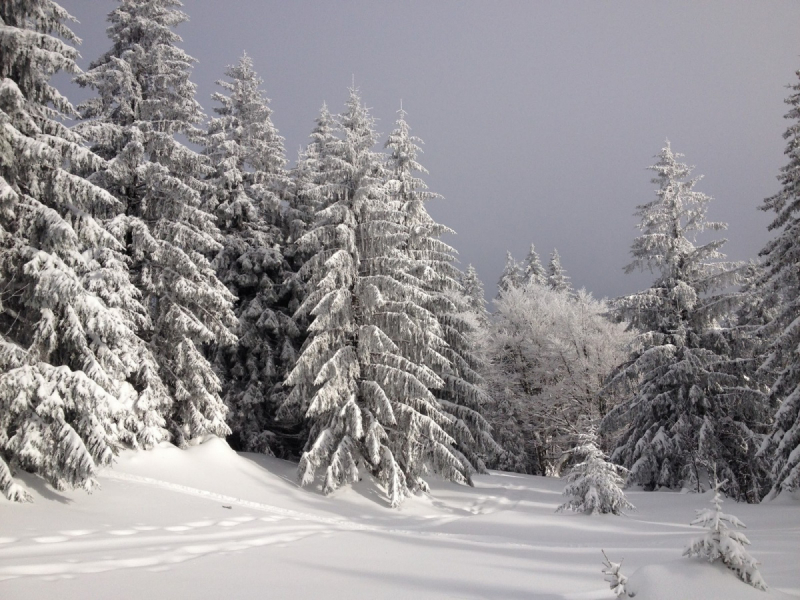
[0,0,800,506]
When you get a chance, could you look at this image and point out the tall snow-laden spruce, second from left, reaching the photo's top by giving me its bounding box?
[76,0,236,447]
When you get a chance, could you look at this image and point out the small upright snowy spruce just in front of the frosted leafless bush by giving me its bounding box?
[557,427,634,515]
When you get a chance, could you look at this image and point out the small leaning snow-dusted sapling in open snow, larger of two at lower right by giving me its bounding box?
[683,481,767,590]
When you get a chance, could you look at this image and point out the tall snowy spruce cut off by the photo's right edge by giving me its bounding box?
[759,65,800,497]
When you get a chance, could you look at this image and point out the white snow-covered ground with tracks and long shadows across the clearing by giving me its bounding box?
[0,438,800,600]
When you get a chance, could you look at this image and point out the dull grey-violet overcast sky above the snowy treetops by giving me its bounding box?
[60,0,800,299]
